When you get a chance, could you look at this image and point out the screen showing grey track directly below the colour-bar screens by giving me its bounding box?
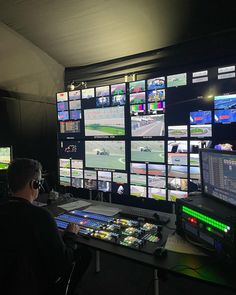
[131,114,165,136]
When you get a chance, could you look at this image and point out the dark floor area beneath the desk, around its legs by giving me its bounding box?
[76,252,235,295]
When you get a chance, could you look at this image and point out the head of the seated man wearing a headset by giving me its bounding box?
[7,158,42,201]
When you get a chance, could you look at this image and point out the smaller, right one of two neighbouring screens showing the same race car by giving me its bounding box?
[131,140,165,163]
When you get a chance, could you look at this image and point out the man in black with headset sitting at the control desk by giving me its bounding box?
[0,158,88,295]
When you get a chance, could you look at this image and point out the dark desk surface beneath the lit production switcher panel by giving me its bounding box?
[45,201,236,294]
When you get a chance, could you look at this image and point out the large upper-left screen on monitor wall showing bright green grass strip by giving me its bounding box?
[84,106,125,136]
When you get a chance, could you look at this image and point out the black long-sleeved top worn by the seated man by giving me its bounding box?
[0,197,77,295]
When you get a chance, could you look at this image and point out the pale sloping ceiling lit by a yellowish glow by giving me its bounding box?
[0,0,236,67]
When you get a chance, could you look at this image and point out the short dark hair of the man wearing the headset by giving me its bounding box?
[7,158,42,193]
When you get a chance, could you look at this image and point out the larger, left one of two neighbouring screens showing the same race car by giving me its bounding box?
[85,140,126,170]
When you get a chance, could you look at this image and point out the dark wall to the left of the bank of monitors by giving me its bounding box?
[0,90,57,183]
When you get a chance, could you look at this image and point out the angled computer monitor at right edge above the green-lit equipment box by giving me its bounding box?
[200,149,236,206]
